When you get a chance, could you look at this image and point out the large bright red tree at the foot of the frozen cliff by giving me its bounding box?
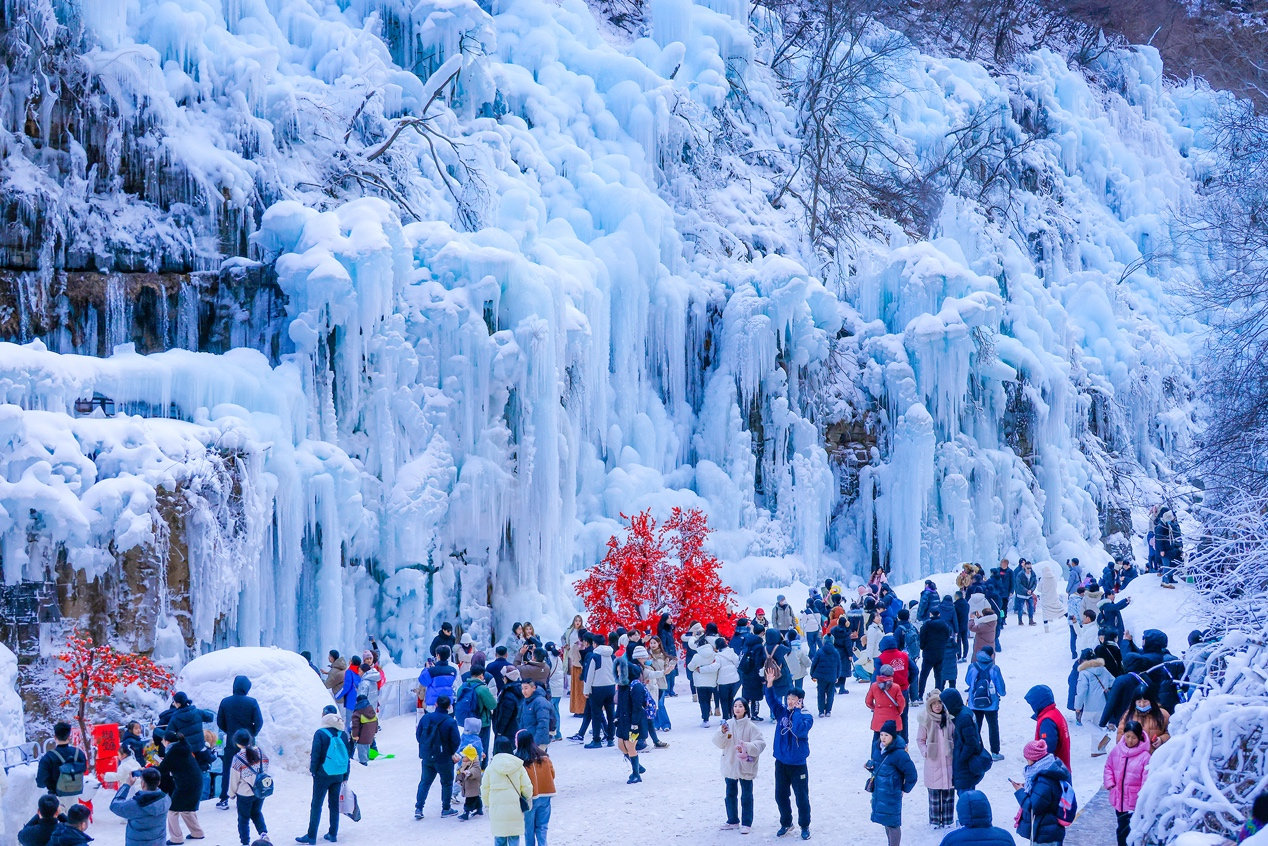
[577,509,735,632]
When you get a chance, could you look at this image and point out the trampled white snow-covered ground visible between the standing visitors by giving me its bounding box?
[90,576,1194,846]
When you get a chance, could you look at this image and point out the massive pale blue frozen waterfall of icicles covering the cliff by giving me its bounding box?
[0,0,1216,663]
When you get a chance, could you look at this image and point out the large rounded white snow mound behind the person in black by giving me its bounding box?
[176,647,331,770]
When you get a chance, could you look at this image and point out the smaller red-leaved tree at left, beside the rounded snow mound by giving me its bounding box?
[55,628,176,750]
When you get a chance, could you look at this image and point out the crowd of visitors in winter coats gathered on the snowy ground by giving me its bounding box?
[19,530,1258,846]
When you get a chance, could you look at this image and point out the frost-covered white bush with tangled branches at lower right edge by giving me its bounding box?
[1132,493,1268,846]
